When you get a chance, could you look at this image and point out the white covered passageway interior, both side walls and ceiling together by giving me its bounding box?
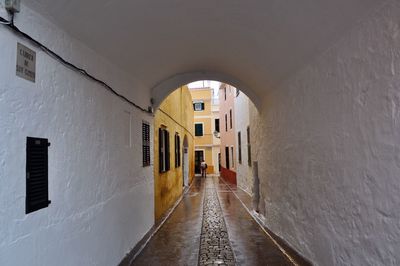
[0,0,400,266]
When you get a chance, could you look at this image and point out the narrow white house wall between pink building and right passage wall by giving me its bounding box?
[235,92,253,194]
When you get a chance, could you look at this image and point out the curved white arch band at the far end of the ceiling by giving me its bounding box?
[151,71,261,109]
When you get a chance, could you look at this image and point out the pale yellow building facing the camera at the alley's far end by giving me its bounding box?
[190,87,220,174]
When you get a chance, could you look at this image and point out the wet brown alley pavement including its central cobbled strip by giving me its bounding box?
[131,177,293,266]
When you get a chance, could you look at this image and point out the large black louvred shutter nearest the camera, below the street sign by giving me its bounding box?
[25,137,51,214]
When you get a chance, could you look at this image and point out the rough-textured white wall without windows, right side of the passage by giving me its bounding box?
[252,1,400,266]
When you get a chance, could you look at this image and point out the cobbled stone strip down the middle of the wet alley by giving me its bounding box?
[199,183,235,266]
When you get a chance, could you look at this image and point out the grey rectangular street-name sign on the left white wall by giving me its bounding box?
[16,43,36,82]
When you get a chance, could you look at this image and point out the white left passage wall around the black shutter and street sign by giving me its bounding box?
[0,6,154,266]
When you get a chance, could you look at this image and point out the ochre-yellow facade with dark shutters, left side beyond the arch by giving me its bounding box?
[154,86,194,221]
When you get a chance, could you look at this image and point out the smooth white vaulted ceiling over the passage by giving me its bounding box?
[25,0,382,100]
